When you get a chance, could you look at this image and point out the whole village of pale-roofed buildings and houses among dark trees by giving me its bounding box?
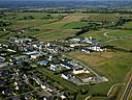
[0,36,108,100]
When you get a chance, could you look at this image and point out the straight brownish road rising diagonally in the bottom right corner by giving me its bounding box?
[120,74,132,100]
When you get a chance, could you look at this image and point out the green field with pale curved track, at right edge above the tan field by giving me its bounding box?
[105,30,132,49]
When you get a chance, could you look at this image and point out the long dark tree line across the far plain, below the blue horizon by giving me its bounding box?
[20,8,132,14]
